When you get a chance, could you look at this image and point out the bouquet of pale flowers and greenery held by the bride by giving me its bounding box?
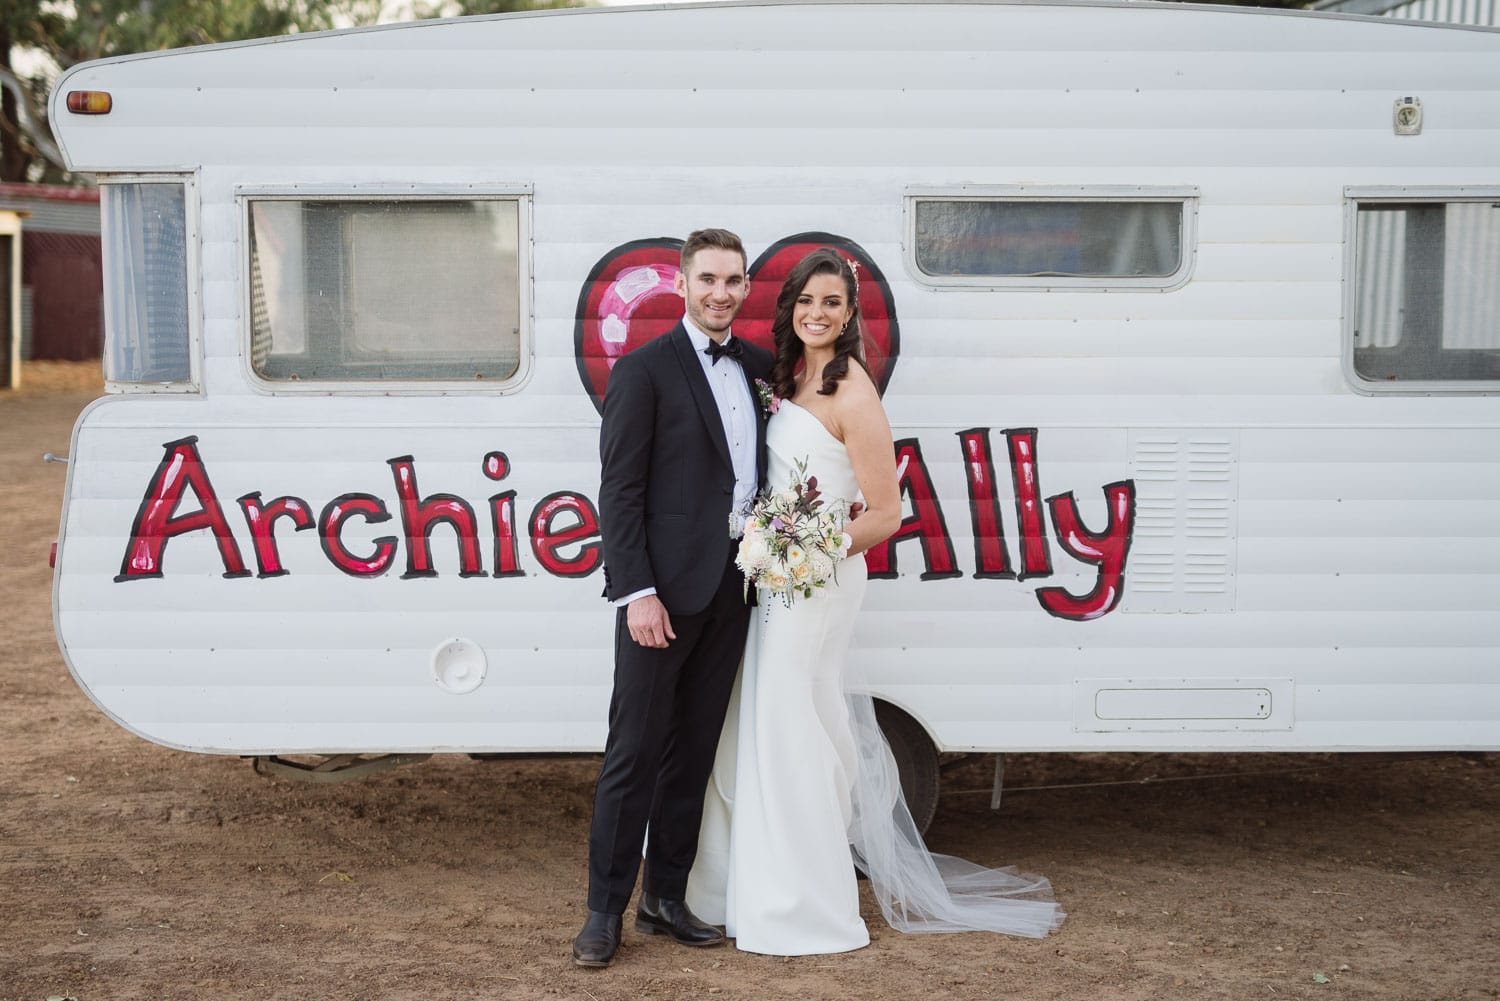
[735,459,849,606]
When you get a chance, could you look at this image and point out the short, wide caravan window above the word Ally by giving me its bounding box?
[908,188,1196,290]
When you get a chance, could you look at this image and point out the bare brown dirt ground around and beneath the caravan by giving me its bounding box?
[0,365,1500,1001]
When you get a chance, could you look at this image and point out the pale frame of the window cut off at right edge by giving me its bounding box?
[1338,185,1500,396]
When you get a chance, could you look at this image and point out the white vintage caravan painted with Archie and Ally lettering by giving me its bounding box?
[53,2,1500,816]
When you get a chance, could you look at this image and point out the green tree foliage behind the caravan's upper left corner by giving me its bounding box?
[0,0,573,182]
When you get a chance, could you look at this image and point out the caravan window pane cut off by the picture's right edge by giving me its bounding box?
[1346,195,1500,392]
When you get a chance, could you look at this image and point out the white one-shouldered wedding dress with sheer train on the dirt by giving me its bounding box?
[687,401,1064,956]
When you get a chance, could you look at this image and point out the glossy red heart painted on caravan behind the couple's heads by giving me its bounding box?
[573,233,900,413]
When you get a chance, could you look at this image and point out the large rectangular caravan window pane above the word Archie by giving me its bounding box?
[248,198,524,384]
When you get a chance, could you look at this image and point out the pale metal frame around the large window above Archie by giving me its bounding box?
[234,183,536,396]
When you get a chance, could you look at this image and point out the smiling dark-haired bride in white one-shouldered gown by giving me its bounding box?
[687,248,1062,956]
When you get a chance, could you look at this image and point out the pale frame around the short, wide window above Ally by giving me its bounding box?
[902,185,1200,293]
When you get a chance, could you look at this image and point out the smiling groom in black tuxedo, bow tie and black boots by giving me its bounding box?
[573,230,771,966]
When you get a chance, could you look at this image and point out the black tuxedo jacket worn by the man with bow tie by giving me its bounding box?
[599,323,771,615]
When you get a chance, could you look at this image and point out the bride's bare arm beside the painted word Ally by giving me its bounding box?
[834,365,902,555]
